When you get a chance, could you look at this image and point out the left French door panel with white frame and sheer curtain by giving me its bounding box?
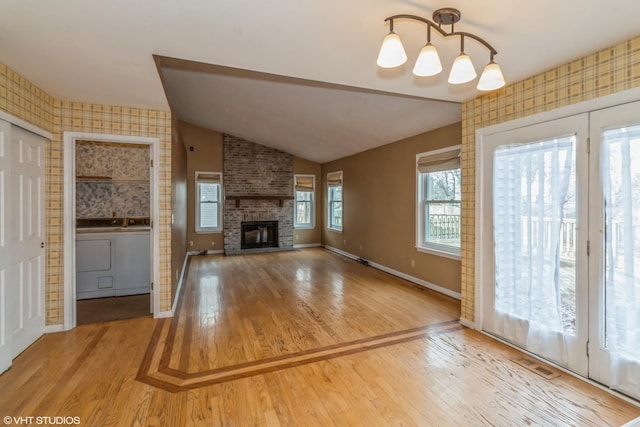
[478,114,589,376]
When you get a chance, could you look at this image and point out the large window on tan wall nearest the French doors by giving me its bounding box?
[416,146,462,258]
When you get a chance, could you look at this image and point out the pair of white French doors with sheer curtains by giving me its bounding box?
[478,102,640,398]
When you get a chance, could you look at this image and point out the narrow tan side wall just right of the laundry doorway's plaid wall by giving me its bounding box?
[171,118,187,297]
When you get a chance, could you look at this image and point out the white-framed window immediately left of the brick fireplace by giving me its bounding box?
[196,172,222,233]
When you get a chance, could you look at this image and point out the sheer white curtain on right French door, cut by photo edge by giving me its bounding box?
[601,126,640,390]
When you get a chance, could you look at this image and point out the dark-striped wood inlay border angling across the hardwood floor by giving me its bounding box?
[136,252,464,392]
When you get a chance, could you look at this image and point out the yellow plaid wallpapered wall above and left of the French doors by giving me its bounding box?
[461,37,640,321]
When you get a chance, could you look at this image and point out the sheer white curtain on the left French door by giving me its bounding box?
[493,136,576,365]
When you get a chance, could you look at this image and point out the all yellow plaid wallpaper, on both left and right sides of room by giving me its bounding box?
[0,37,640,325]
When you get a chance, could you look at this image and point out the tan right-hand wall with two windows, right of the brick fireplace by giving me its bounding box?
[322,123,464,292]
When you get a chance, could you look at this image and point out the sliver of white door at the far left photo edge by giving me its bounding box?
[0,120,13,372]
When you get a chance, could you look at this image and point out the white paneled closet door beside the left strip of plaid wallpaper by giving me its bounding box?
[7,126,45,357]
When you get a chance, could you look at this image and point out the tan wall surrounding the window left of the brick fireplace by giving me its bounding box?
[178,122,224,251]
